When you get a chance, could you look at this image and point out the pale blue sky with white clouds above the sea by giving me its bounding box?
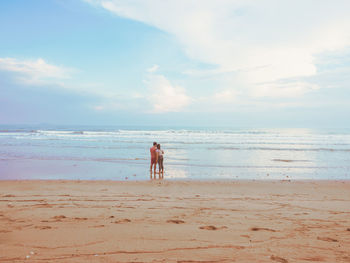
[0,0,350,128]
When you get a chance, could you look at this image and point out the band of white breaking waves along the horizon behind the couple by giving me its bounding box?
[0,129,350,145]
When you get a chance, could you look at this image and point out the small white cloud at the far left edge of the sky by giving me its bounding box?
[0,58,73,85]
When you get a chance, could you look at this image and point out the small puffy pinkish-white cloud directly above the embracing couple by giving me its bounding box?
[145,75,191,113]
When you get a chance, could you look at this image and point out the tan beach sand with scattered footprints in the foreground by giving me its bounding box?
[0,180,350,263]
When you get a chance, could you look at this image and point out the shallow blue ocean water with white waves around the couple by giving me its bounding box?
[0,125,350,180]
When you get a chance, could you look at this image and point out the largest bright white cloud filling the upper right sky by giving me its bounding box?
[85,0,350,100]
